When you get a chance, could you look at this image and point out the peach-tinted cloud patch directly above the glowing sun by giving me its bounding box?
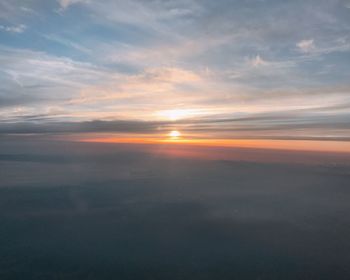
[70,67,202,109]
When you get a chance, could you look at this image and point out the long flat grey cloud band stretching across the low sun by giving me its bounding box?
[0,109,350,141]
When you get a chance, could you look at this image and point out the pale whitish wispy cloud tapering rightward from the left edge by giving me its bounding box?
[0,47,113,111]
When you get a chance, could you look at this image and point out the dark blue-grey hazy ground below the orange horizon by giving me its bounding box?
[0,140,350,280]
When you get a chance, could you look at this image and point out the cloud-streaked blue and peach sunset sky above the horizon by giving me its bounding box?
[0,0,350,150]
